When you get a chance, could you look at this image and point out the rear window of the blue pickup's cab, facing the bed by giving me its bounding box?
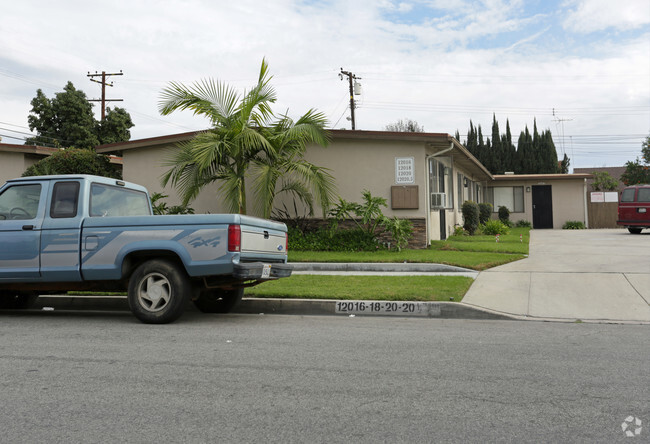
[90,183,151,217]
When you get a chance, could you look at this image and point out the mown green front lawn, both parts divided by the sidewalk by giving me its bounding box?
[256,228,530,302]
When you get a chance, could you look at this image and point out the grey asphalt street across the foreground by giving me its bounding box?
[0,311,650,443]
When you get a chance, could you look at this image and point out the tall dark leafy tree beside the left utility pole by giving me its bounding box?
[25,82,133,148]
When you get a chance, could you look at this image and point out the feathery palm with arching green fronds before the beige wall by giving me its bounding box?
[159,60,334,217]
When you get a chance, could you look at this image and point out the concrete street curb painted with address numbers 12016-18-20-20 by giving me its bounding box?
[34,295,516,320]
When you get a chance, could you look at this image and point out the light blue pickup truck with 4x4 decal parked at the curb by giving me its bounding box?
[0,175,292,324]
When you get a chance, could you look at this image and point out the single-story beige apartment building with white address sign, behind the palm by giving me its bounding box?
[97,130,591,247]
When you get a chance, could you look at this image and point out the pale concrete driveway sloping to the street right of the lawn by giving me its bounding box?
[463,229,650,322]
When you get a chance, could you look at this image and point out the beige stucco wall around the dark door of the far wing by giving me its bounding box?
[489,179,587,229]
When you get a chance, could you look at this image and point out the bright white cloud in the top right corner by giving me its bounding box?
[563,0,650,34]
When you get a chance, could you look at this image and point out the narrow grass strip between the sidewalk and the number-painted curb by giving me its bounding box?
[244,275,473,302]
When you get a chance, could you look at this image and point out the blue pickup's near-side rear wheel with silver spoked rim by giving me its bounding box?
[128,259,191,324]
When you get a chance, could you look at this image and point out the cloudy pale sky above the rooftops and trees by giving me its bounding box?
[0,0,650,167]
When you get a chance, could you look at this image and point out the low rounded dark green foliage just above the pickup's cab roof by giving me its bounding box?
[23,148,122,179]
